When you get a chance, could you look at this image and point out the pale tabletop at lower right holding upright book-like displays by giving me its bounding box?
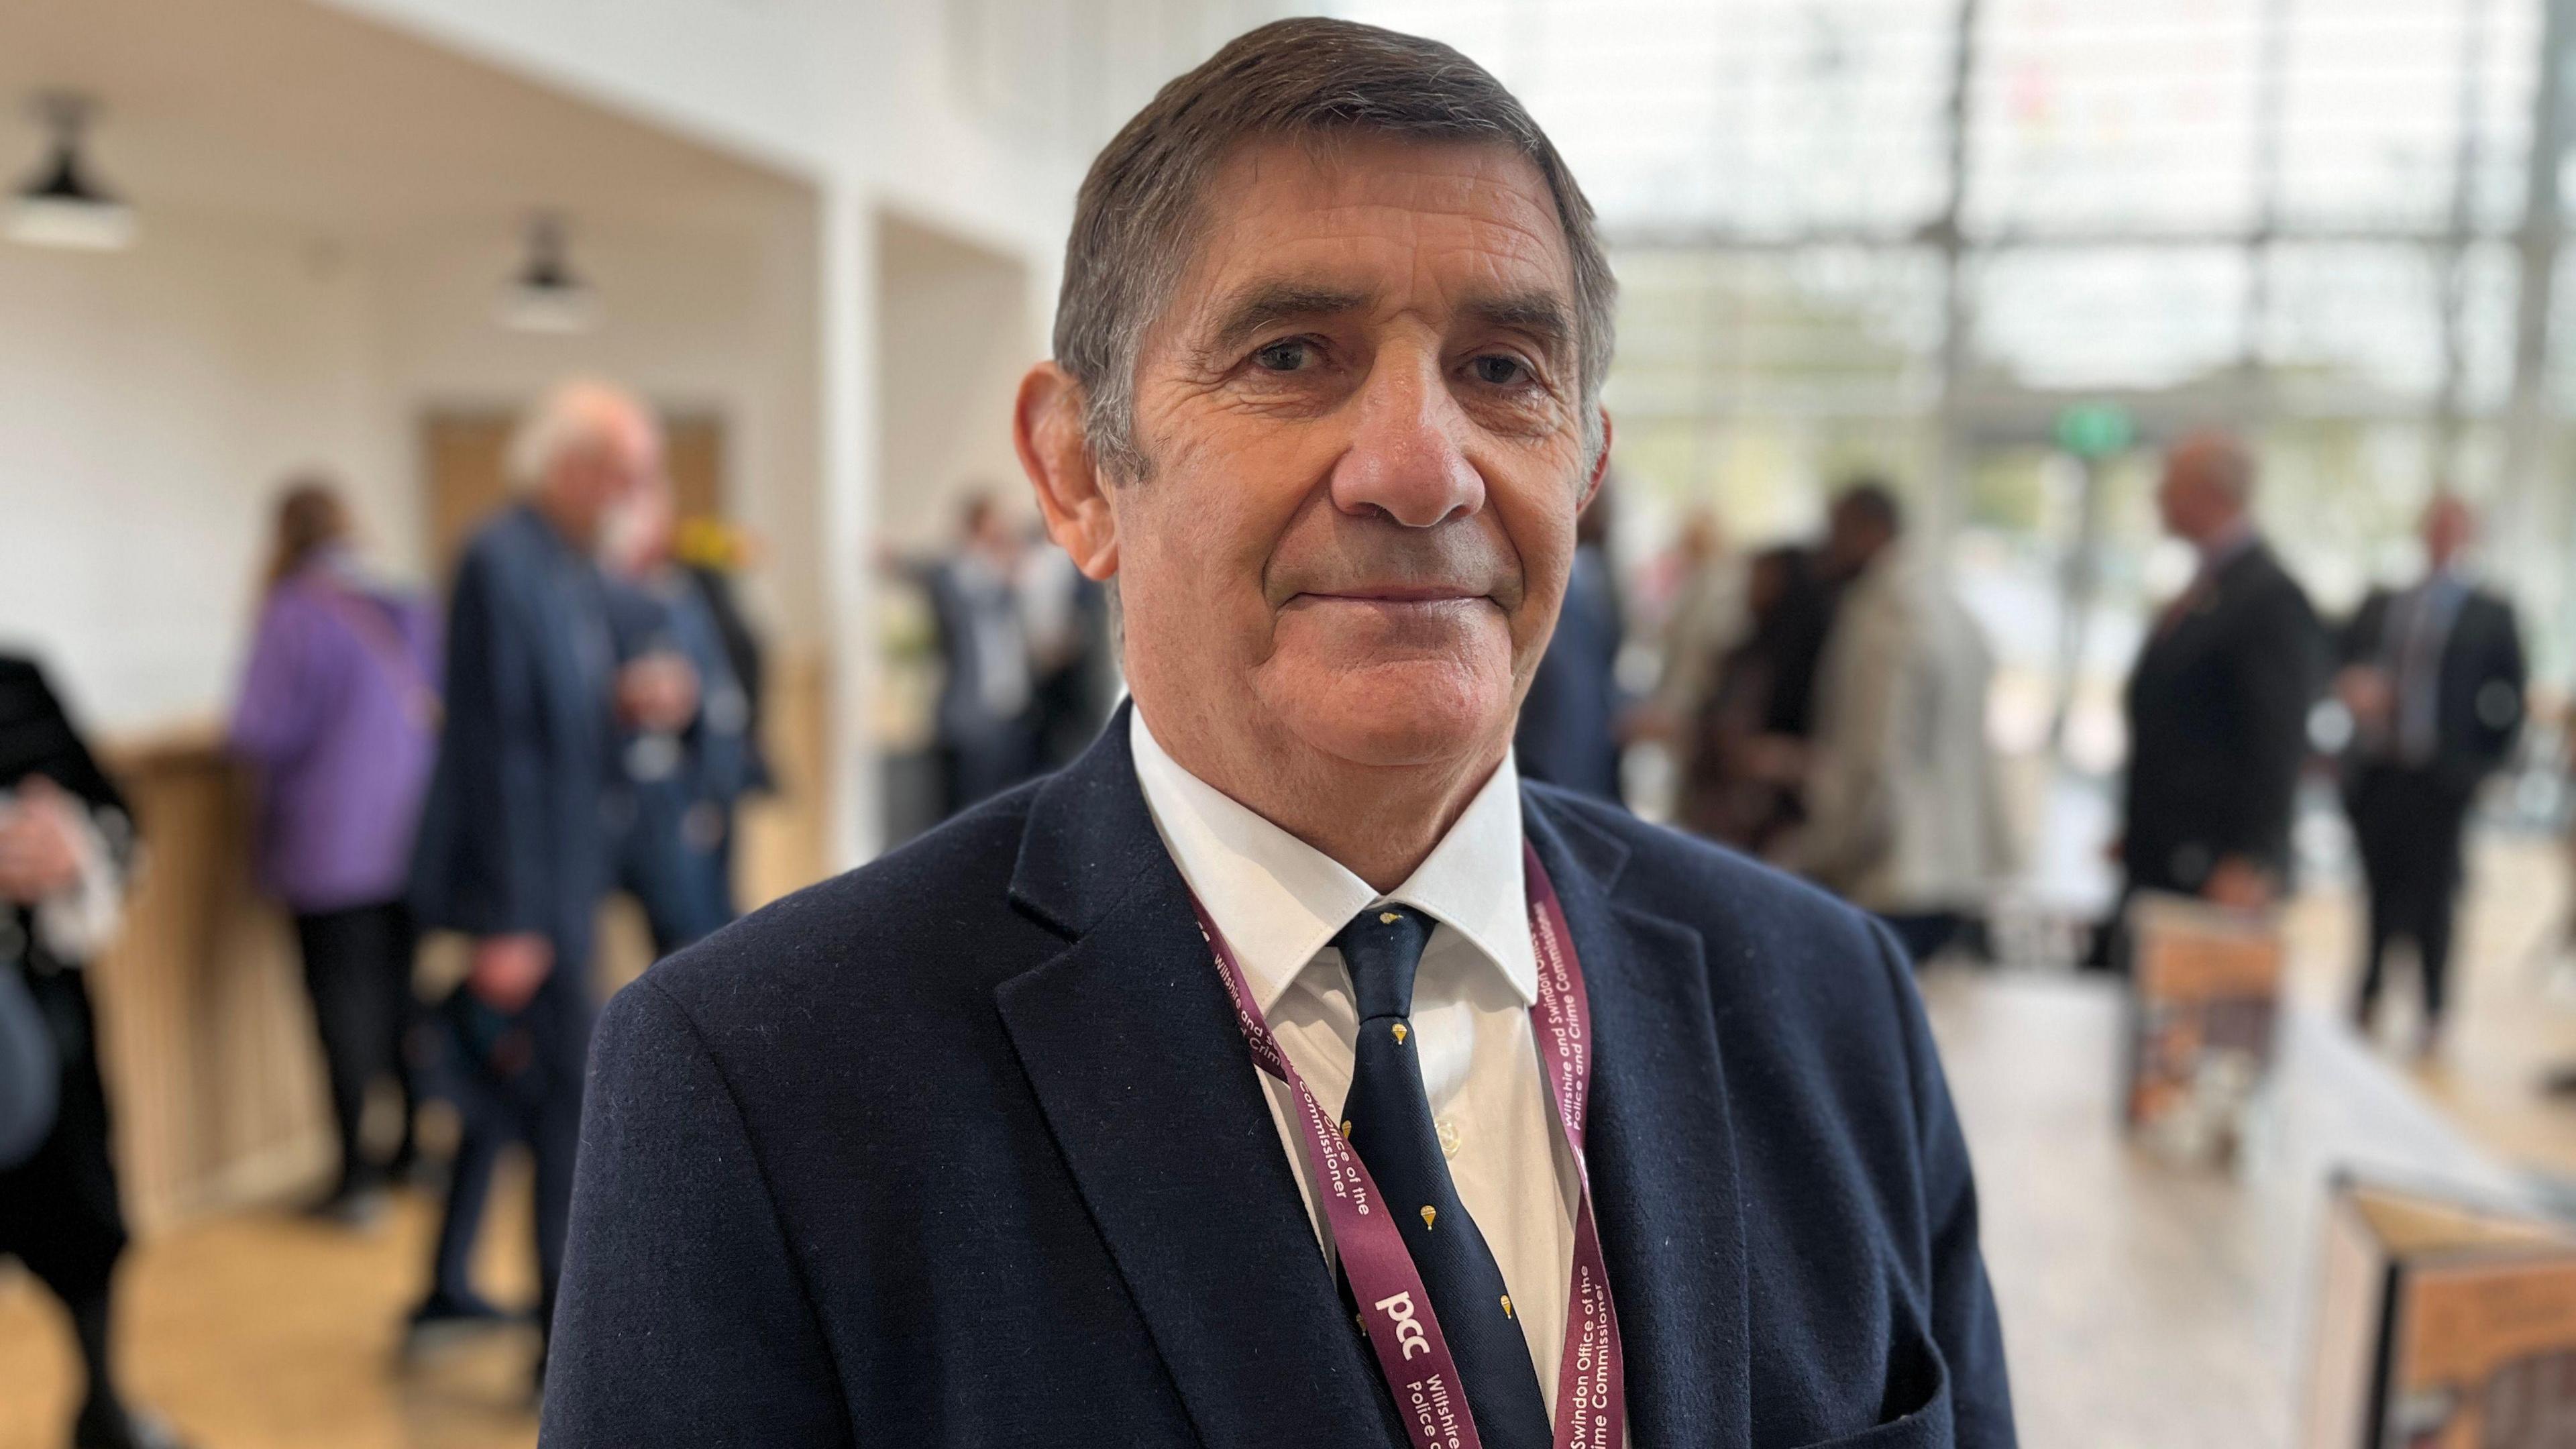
[1924,972,2530,1449]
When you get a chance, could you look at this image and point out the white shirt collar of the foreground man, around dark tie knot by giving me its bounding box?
[1128,709,1538,1011]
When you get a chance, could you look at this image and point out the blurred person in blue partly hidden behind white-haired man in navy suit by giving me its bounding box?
[608,480,752,957]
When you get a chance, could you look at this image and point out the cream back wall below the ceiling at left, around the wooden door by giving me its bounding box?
[0,203,824,733]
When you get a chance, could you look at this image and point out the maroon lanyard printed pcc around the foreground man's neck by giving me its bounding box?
[1190,841,1628,1449]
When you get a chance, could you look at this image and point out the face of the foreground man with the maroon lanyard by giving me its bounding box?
[1110,140,1592,765]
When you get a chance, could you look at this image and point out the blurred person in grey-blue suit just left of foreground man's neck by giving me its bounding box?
[904,492,1038,815]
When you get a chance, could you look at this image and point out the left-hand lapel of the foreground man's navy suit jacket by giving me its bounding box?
[997,709,1399,1446]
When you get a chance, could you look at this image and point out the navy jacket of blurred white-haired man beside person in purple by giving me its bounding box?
[410,505,623,964]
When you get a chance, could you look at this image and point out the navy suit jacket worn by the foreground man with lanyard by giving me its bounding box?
[543,701,2012,1449]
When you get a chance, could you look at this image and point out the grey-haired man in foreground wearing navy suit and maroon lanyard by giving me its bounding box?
[546,21,2012,1446]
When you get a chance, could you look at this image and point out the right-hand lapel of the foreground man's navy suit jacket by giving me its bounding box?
[1522,792,1752,1446]
